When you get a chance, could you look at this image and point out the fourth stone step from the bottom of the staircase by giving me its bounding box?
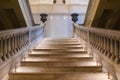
[23,56,93,62]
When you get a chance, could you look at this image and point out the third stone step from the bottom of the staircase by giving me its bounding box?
[21,59,100,67]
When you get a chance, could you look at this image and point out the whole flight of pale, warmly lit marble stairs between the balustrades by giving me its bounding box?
[9,38,110,80]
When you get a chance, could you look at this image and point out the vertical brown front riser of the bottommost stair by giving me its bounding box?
[9,74,107,80]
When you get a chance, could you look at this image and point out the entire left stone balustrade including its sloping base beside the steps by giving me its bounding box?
[0,25,44,79]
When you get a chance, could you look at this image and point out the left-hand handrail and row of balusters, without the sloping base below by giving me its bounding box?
[0,25,44,64]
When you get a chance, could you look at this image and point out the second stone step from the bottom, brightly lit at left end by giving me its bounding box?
[10,66,102,74]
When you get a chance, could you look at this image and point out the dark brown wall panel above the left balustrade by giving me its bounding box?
[0,0,26,30]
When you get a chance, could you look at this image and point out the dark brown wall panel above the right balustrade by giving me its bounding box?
[92,0,120,30]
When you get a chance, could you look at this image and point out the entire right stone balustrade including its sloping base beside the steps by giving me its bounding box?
[74,24,120,79]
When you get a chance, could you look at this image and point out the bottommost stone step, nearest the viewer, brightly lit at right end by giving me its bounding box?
[10,72,110,80]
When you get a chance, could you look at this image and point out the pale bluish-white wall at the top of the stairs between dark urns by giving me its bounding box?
[45,14,73,37]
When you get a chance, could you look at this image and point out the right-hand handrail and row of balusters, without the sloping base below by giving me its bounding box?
[74,24,120,64]
